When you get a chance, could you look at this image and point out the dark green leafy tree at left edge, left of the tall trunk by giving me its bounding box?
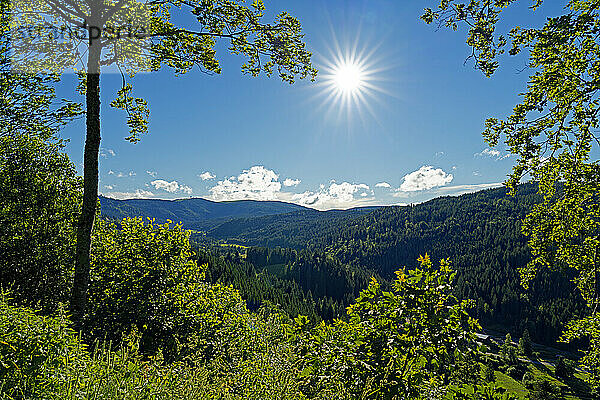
[0,133,81,311]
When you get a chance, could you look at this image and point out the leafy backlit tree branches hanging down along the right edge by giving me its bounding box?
[424,0,600,387]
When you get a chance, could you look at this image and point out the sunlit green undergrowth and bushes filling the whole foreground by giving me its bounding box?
[0,136,596,400]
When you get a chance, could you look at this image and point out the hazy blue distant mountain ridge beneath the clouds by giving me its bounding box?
[100,196,314,230]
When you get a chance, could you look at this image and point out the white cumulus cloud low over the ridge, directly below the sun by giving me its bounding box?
[292,182,369,209]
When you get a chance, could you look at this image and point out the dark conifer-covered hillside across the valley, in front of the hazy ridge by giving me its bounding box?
[207,185,585,344]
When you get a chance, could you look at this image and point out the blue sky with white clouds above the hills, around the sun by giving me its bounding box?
[59,0,560,209]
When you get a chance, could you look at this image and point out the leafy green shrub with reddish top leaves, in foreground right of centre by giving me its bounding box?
[298,255,478,398]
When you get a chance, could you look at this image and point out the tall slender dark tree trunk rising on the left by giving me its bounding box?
[71,35,102,329]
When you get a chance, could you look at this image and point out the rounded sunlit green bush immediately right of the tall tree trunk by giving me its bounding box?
[85,218,248,361]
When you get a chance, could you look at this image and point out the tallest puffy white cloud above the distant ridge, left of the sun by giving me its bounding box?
[209,165,281,201]
